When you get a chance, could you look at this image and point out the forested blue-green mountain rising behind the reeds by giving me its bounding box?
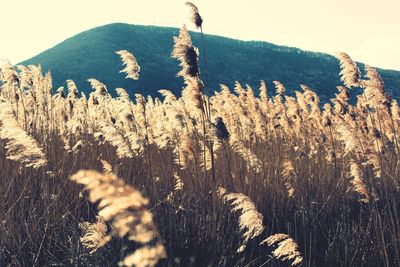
[20,23,400,100]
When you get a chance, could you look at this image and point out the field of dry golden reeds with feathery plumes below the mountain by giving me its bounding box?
[0,4,400,267]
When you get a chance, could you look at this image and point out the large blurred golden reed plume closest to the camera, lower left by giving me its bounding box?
[70,170,166,266]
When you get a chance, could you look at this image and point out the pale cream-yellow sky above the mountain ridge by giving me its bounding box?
[0,0,400,70]
